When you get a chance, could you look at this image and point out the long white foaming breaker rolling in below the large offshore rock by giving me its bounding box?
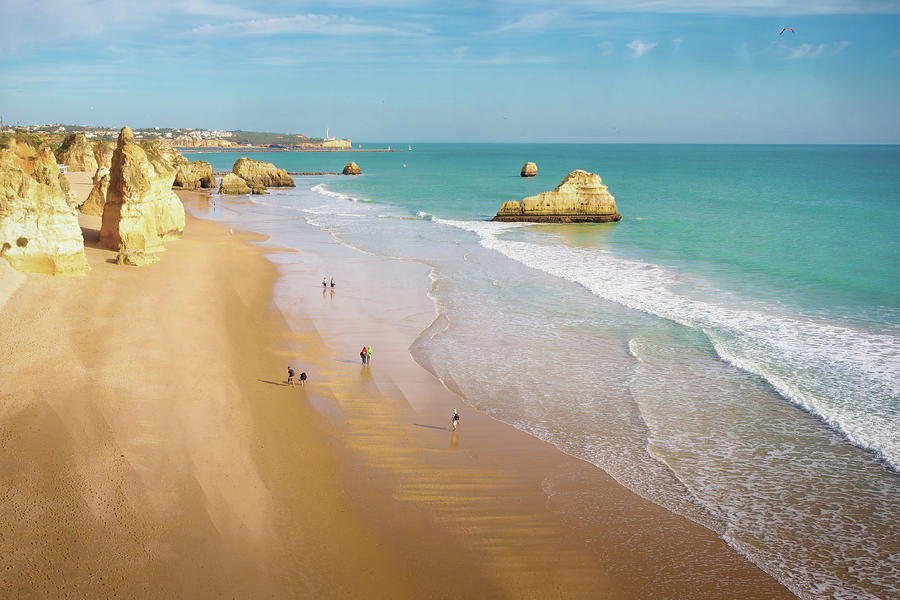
[434,218,900,471]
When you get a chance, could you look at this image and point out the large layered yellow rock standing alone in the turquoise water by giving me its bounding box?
[494,169,622,223]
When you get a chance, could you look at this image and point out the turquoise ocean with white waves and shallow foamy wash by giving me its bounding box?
[188,143,900,598]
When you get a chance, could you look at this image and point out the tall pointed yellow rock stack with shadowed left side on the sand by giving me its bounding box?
[100,127,184,256]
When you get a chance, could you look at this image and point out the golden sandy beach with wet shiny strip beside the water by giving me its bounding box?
[0,174,793,598]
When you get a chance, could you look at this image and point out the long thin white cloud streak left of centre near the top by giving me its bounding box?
[190,14,428,37]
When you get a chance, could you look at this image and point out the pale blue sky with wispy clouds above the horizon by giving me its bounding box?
[0,0,900,144]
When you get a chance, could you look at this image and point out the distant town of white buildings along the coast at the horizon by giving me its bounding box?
[0,122,353,150]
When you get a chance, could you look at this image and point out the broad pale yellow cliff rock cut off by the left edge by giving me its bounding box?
[0,137,90,275]
